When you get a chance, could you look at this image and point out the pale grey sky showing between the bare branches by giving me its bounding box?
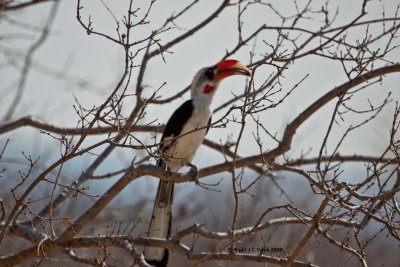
[0,1,400,193]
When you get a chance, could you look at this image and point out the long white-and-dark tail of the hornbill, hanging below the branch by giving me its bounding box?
[144,180,174,267]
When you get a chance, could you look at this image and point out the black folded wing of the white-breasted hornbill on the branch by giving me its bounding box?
[158,100,193,165]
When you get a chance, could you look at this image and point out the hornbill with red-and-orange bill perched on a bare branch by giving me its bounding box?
[144,59,251,267]
